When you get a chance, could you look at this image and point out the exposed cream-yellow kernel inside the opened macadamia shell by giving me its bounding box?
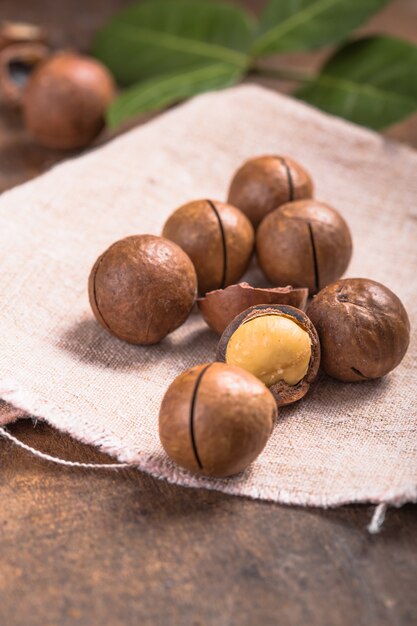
[226,314,311,387]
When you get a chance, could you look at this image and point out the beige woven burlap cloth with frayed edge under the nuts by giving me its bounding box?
[0,86,417,506]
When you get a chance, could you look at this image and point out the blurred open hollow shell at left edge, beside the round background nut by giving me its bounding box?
[0,43,50,106]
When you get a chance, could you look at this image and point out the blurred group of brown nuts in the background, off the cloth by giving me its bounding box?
[0,22,115,150]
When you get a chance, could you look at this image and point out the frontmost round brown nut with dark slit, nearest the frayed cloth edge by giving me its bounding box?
[159,363,277,477]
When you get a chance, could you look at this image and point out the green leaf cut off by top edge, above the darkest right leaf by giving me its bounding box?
[252,0,387,56]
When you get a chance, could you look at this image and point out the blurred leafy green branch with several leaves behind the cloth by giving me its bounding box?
[93,0,417,129]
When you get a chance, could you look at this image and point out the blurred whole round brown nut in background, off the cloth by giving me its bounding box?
[23,52,115,150]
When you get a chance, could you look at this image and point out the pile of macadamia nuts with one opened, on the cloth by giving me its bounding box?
[89,156,410,477]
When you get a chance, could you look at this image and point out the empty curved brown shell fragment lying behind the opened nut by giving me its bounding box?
[197,283,308,335]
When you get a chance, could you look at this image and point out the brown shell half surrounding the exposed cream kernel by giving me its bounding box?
[216,304,320,406]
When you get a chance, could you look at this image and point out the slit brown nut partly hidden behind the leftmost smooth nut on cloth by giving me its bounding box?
[162,200,254,294]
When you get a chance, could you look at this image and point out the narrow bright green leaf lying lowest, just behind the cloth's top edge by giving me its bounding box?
[107,63,242,128]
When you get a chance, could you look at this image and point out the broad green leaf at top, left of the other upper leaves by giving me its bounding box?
[93,0,254,85]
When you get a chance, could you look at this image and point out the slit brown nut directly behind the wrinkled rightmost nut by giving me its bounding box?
[256,200,352,294]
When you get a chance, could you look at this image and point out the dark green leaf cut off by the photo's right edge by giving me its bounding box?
[295,37,417,130]
